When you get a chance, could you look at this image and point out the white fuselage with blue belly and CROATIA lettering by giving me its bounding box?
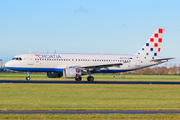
[5,53,167,73]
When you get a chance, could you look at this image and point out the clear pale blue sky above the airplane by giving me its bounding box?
[0,0,180,64]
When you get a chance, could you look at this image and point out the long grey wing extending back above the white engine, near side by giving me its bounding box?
[71,62,123,71]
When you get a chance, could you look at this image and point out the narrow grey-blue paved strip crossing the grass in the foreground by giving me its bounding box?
[0,111,180,114]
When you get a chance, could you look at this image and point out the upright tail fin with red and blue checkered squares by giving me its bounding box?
[136,29,165,56]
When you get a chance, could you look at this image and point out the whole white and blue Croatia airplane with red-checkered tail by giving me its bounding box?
[5,28,174,82]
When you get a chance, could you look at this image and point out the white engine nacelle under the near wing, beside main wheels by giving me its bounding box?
[63,68,82,78]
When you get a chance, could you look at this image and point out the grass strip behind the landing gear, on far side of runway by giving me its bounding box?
[0,73,180,81]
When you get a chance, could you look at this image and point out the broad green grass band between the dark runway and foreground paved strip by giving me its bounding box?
[0,84,180,111]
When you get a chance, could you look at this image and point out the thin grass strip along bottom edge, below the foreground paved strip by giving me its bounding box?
[0,114,180,120]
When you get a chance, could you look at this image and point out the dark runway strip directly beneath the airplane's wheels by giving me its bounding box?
[0,80,180,85]
